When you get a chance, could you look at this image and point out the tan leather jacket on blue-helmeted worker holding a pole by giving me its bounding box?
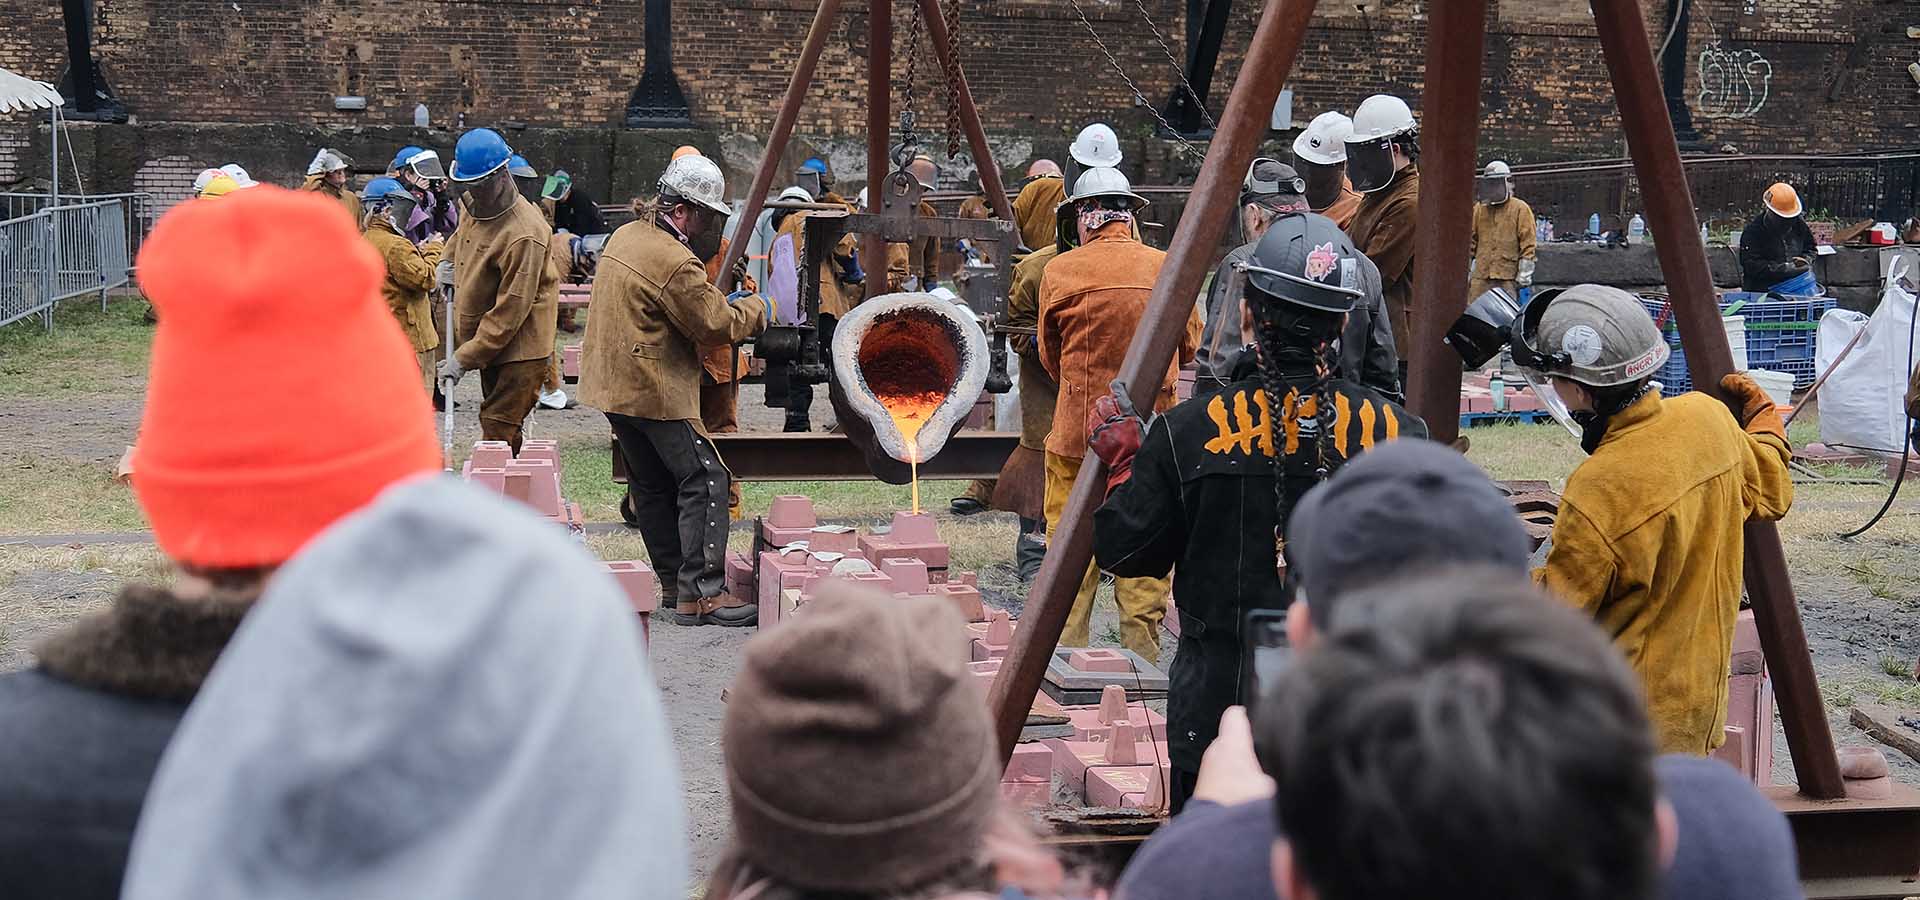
[447,196,561,370]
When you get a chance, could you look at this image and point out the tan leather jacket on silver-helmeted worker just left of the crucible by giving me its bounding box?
[580,221,766,422]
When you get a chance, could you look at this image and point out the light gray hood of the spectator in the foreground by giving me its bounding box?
[121,478,687,900]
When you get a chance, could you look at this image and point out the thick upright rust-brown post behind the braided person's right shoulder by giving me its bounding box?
[1400,0,1486,443]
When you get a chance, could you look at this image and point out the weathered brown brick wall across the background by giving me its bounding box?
[0,0,1920,193]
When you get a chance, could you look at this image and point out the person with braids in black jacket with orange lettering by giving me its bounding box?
[1087,213,1427,812]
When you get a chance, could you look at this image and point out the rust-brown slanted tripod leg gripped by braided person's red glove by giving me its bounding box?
[989,0,1315,760]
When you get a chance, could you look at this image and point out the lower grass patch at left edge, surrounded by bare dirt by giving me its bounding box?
[0,457,146,535]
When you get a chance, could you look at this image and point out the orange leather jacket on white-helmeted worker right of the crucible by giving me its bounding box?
[1035,223,1200,459]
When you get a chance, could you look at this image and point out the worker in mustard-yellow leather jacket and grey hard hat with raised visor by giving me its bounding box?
[1450,284,1793,754]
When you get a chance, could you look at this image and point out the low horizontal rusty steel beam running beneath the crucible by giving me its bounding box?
[612,432,1020,484]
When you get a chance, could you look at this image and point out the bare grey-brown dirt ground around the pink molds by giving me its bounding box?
[0,305,1920,875]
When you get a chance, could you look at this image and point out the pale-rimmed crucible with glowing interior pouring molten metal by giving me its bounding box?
[831,294,987,462]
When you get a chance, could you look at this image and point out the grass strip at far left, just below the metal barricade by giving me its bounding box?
[0,294,154,397]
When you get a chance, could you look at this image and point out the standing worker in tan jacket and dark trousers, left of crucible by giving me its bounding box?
[580,155,766,626]
